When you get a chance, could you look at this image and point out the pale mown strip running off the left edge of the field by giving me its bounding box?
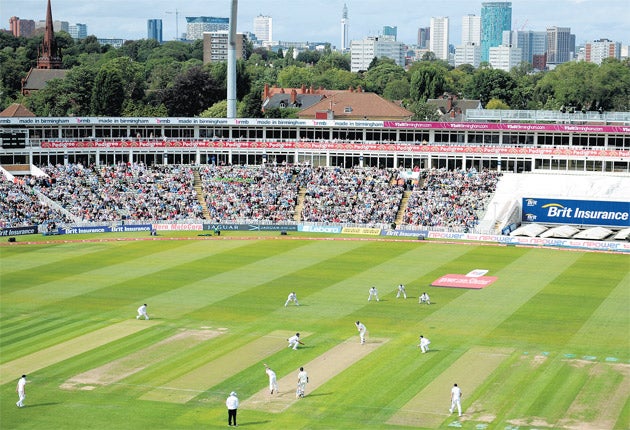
[0,319,161,385]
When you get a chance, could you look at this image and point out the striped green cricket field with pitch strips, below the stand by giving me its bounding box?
[0,232,630,430]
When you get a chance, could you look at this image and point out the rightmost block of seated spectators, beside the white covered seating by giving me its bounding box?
[403,168,500,229]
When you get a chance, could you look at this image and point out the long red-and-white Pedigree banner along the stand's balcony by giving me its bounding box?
[41,139,630,158]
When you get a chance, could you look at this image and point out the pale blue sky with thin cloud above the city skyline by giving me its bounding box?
[0,0,630,47]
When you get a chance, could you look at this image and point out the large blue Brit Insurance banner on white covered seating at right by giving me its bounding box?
[523,198,630,227]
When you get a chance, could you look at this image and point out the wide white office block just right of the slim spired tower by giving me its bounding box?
[350,36,405,73]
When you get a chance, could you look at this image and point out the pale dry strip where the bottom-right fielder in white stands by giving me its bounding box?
[387,347,513,428]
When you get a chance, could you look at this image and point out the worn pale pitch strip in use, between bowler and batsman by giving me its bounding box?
[240,336,389,413]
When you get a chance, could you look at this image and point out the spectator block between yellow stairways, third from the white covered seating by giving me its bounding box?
[199,164,299,222]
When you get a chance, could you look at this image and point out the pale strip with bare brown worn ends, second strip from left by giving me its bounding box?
[61,330,222,390]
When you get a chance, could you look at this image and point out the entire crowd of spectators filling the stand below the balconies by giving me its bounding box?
[0,163,500,229]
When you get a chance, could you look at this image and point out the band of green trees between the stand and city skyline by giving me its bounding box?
[0,32,630,120]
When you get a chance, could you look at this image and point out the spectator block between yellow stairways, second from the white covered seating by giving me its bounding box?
[302,167,403,225]
